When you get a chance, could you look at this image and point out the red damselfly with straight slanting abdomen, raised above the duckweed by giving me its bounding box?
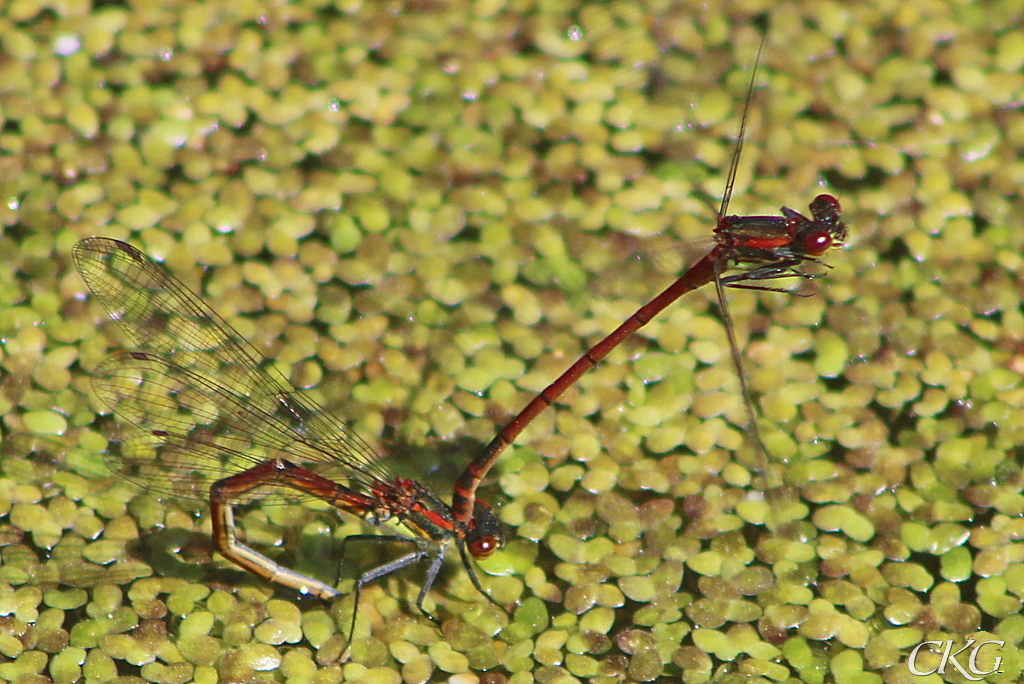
[452,39,846,524]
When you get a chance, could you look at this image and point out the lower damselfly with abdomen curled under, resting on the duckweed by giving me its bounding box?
[72,238,504,637]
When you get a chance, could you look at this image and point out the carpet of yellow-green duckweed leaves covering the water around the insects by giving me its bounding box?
[6,0,1024,684]
